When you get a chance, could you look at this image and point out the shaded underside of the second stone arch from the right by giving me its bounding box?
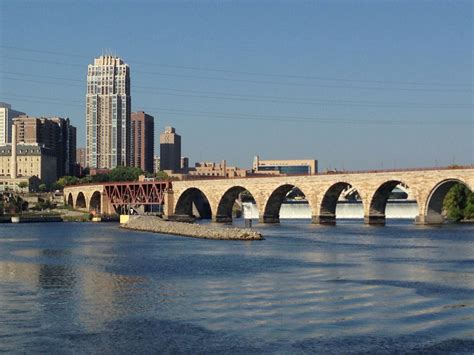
[364,179,418,224]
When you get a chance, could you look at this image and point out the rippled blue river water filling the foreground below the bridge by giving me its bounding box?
[0,220,474,354]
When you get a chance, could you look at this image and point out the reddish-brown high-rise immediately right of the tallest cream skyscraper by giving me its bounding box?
[131,111,155,173]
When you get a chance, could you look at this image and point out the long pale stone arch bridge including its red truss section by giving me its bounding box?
[64,167,474,224]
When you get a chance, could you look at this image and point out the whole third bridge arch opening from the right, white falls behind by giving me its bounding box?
[313,181,364,225]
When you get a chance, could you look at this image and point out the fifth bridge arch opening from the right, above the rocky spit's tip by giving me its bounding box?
[214,186,258,223]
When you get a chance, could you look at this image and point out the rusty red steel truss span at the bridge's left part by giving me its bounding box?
[104,181,171,207]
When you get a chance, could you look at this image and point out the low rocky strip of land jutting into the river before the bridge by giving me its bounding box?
[121,216,264,240]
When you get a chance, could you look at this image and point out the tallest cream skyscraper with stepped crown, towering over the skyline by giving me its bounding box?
[86,55,131,169]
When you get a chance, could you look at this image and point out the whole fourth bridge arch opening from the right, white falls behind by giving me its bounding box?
[260,184,311,223]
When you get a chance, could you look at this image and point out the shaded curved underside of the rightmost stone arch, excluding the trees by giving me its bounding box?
[424,178,472,224]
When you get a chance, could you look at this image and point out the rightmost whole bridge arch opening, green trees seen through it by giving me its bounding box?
[424,179,474,224]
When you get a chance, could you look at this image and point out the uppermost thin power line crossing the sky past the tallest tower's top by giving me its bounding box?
[0,44,472,87]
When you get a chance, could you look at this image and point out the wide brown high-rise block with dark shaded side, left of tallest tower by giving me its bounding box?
[13,115,76,178]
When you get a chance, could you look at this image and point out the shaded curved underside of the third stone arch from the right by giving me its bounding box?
[313,181,364,224]
